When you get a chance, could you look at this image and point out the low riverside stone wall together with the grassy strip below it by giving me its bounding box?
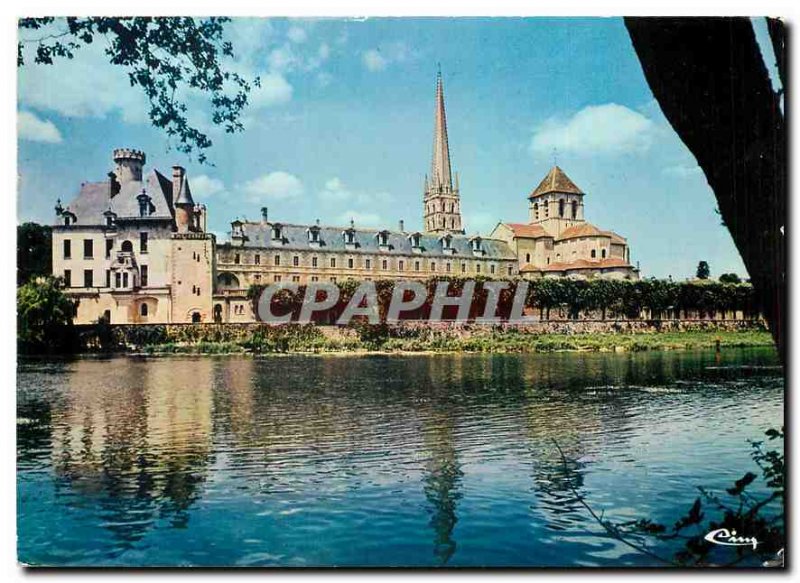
[76,320,771,353]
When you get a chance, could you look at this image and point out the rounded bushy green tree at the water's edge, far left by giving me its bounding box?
[17,277,77,353]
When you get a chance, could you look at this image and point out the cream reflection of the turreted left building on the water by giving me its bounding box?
[51,360,213,543]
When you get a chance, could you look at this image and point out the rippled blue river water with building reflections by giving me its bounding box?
[17,349,783,566]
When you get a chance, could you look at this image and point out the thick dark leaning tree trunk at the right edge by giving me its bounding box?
[625,18,787,361]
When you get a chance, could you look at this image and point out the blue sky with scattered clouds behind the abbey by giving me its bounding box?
[18,18,760,279]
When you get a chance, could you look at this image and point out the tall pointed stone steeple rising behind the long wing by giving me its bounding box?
[423,69,464,233]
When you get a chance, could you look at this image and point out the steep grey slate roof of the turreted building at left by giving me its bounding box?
[64,170,175,226]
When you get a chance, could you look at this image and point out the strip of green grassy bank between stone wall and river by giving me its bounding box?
[130,327,773,354]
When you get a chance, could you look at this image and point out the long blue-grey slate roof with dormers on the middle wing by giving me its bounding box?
[225,222,516,260]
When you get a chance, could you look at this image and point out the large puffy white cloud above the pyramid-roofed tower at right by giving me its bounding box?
[530,103,656,156]
